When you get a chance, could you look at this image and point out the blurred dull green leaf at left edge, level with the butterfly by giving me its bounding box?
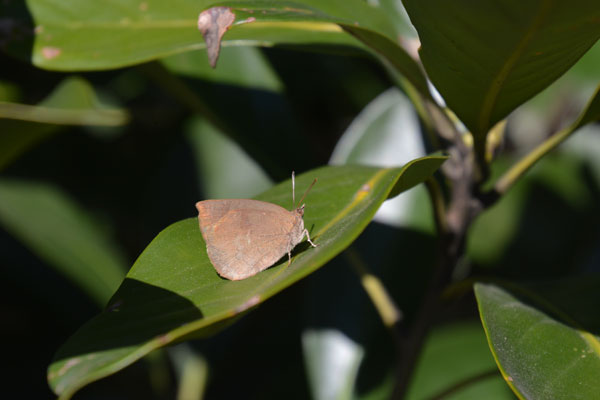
[0,179,126,306]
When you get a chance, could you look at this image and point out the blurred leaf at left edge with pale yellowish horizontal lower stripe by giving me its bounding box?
[0,78,128,170]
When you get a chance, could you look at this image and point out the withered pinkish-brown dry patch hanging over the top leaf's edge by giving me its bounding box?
[198,7,235,68]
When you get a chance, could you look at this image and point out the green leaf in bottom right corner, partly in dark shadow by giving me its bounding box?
[475,277,600,400]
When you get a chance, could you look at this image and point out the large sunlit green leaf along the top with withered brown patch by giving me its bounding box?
[21,0,428,94]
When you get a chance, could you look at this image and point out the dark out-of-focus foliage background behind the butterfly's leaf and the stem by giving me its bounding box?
[0,1,600,399]
